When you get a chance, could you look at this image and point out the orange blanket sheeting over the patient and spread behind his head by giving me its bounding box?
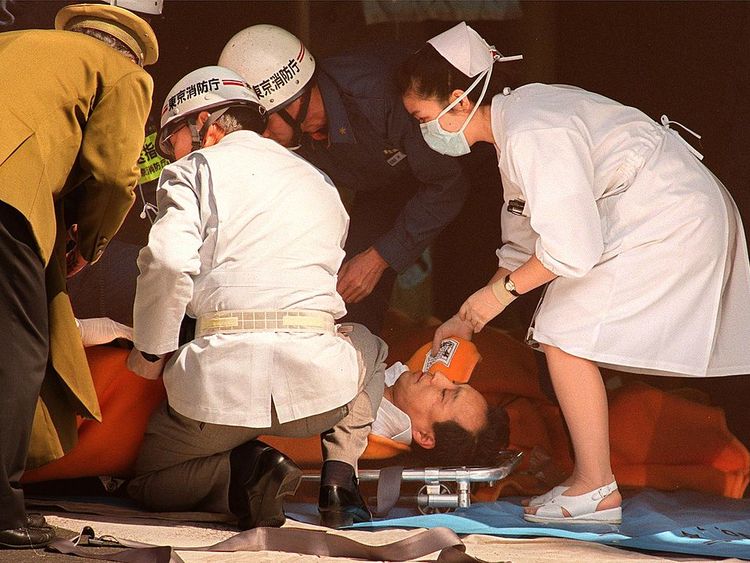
[23,315,750,500]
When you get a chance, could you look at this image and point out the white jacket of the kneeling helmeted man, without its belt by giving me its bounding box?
[133,131,359,428]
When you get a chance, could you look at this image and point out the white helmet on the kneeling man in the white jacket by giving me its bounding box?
[157,66,266,156]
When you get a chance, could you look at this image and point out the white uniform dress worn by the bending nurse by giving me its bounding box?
[492,84,750,376]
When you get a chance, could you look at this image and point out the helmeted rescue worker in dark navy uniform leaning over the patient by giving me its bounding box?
[219,25,468,333]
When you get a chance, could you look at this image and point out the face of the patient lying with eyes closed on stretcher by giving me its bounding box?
[393,371,487,440]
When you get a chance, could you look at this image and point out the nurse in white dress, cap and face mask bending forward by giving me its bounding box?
[400,23,750,523]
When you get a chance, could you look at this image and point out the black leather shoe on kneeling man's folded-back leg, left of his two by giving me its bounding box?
[229,440,302,530]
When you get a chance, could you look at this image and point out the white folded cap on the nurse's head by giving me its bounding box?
[427,22,523,78]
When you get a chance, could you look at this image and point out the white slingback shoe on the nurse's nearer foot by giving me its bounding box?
[523,481,622,524]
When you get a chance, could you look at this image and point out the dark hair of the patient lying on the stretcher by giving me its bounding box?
[412,407,510,467]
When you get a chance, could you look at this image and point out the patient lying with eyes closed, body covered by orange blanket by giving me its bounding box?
[23,326,509,498]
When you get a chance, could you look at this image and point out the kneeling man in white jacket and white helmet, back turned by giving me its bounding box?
[128,66,387,529]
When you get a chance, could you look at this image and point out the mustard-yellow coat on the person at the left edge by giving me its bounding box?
[0,30,153,467]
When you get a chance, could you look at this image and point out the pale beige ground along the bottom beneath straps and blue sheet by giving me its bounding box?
[0,513,738,563]
